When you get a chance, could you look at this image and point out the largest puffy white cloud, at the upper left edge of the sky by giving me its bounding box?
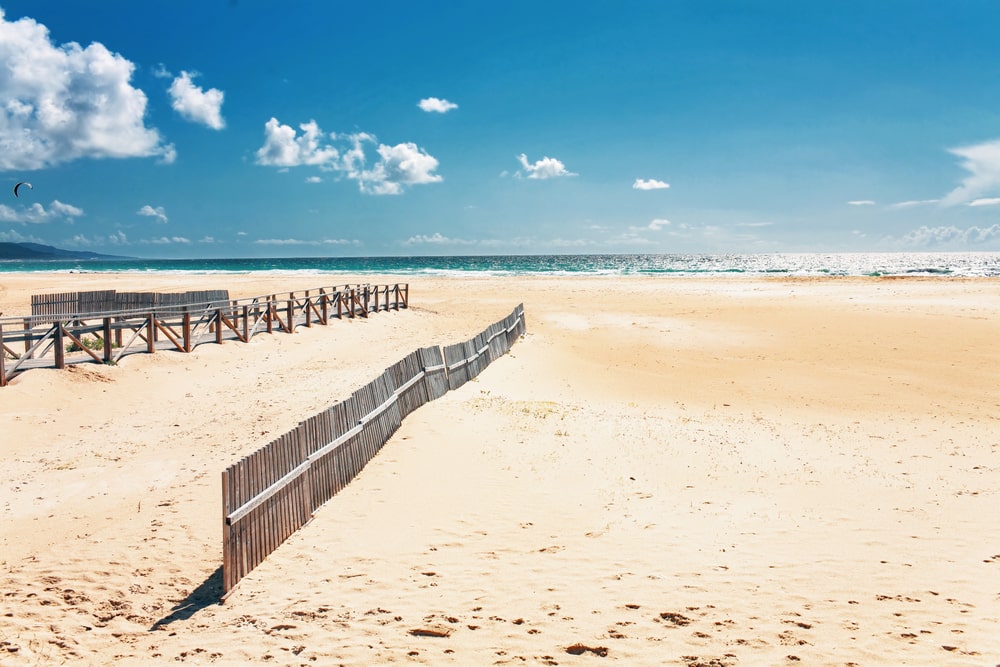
[0,9,174,171]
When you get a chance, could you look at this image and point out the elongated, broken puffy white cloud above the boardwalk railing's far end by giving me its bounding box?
[257,118,443,195]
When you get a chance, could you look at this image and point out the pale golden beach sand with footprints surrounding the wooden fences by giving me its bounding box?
[0,274,1000,665]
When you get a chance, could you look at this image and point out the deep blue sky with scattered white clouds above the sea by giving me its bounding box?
[0,0,1000,257]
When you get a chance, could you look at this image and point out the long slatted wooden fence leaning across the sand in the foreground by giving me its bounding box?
[222,304,525,593]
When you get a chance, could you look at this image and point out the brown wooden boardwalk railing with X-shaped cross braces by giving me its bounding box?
[0,284,410,387]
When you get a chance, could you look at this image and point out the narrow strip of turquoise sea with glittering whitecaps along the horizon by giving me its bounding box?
[0,252,1000,279]
